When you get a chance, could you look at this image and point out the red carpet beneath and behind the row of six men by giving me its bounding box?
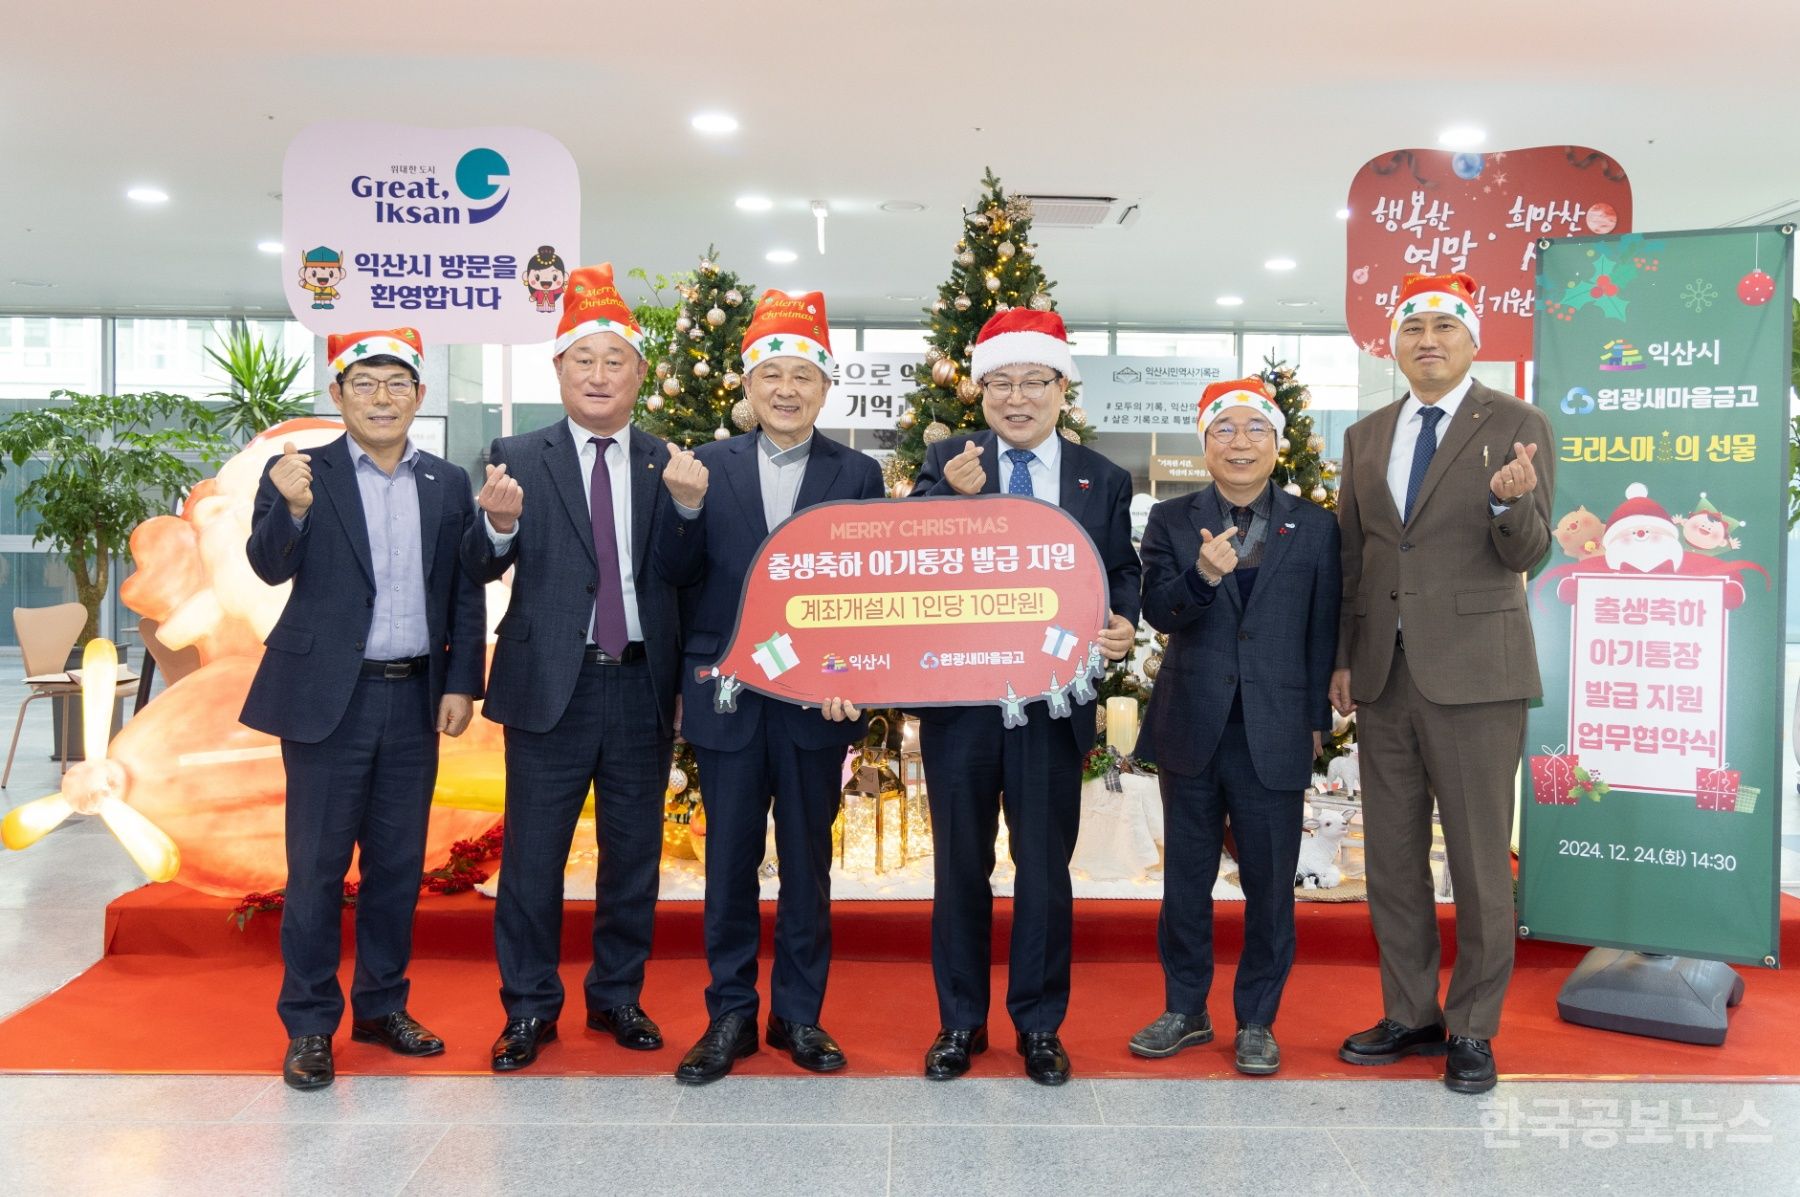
[0,886,1800,1082]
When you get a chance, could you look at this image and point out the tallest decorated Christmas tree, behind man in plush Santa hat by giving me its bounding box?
[887,171,1091,495]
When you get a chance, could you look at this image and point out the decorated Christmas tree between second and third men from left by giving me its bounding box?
[639,247,756,448]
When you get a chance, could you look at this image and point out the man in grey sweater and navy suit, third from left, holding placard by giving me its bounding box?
[657,290,884,1084]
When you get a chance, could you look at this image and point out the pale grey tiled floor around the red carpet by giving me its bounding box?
[0,673,1800,1197]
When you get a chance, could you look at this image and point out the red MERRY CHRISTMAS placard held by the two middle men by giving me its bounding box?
[698,495,1107,727]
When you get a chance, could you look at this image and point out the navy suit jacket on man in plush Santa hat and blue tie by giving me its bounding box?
[913,430,1143,752]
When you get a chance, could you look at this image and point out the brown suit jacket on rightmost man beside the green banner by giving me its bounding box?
[1337,382,1557,706]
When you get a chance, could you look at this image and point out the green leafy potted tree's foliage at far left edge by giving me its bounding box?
[0,391,227,633]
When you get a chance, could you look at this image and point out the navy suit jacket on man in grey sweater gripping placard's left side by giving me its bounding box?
[657,430,886,752]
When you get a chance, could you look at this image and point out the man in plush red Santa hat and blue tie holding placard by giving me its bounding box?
[913,308,1139,1085]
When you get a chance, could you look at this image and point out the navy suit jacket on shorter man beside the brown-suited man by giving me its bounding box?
[1143,486,1341,790]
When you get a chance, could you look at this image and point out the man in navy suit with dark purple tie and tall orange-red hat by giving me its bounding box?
[463,265,680,1073]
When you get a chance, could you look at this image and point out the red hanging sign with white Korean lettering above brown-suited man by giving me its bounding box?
[1345,146,1631,362]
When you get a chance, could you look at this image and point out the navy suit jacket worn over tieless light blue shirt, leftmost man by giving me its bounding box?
[238,436,488,743]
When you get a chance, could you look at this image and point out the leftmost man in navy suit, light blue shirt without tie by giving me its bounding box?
[238,328,486,1089]
